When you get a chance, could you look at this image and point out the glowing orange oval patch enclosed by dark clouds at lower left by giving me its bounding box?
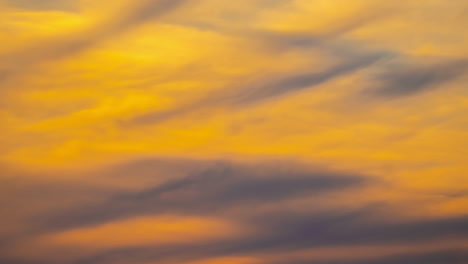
[39,216,242,250]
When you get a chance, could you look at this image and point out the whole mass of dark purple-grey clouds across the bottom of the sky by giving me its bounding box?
[0,160,468,264]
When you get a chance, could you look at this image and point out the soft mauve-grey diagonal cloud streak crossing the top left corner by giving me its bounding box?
[0,0,184,85]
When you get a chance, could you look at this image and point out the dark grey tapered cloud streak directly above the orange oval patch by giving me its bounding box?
[44,161,367,233]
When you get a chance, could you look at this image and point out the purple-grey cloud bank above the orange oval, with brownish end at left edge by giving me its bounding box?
[0,160,368,263]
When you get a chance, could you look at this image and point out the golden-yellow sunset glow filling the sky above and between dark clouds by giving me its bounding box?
[0,0,468,264]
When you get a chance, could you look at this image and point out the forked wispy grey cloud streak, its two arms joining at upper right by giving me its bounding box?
[120,3,393,127]
